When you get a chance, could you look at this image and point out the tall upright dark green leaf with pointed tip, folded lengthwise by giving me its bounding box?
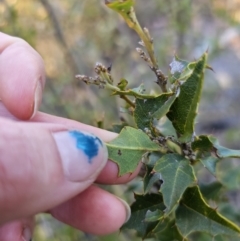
[167,53,207,142]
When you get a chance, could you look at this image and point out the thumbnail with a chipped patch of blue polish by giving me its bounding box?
[53,130,108,182]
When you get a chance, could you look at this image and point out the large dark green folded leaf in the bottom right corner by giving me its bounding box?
[176,186,240,238]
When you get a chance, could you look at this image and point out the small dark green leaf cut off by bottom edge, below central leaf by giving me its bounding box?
[152,218,185,241]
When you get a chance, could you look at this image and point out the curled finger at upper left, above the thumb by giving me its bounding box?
[0,32,45,120]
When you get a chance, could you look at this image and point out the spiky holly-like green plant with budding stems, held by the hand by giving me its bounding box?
[76,0,240,241]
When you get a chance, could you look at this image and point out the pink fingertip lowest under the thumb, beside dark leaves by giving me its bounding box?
[50,186,130,235]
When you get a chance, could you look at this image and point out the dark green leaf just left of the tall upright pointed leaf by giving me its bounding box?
[133,93,173,130]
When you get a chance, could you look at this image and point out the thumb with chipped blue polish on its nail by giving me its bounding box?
[0,118,107,225]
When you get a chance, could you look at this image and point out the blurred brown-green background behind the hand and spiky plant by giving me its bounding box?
[0,0,240,241]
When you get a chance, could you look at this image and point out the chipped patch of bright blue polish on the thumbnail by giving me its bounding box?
[69,130,103,164]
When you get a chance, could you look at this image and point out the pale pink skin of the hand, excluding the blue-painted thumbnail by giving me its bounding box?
[0,33,139,241]
